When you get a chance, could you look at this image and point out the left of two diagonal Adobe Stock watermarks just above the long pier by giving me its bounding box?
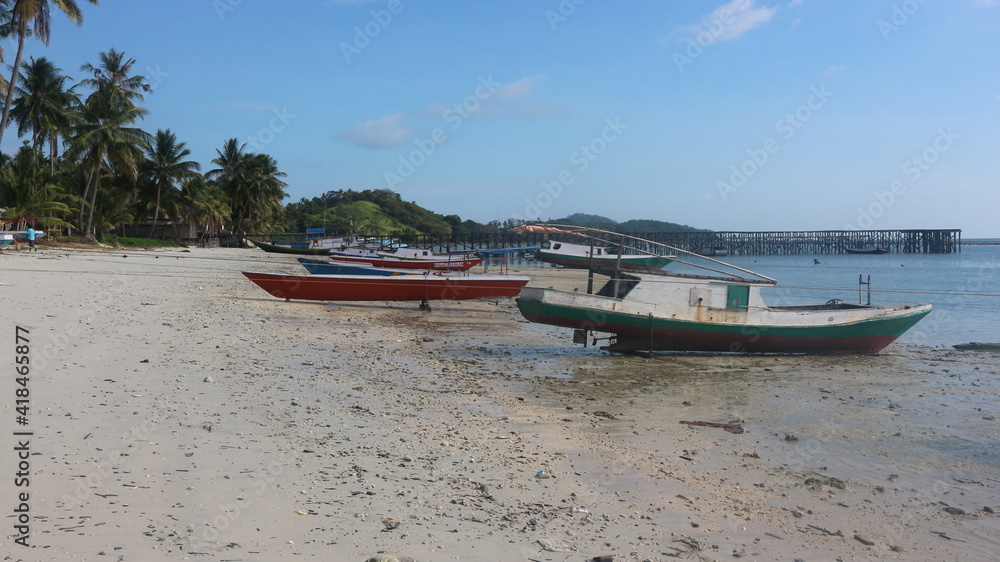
[715,85,833,202]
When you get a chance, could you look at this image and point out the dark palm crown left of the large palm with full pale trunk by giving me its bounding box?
[10,57,76,174]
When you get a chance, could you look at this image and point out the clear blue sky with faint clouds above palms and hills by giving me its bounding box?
[3,0,1000,238]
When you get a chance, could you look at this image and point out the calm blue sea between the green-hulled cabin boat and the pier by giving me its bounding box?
[519,245,1000,346]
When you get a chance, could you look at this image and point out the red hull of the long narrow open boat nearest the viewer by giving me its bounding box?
[243,271,529,301]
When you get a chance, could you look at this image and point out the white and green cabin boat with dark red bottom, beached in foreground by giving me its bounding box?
[517,222,931,353]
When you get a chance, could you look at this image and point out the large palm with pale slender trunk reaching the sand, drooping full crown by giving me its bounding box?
[70,83,150,239]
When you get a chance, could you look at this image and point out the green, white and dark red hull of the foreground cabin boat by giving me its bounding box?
[517,289,931,353]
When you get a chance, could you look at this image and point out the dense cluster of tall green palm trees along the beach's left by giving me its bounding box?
[0,0,287,241]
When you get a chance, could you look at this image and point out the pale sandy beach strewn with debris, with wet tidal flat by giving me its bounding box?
[0,246,1000,562]
